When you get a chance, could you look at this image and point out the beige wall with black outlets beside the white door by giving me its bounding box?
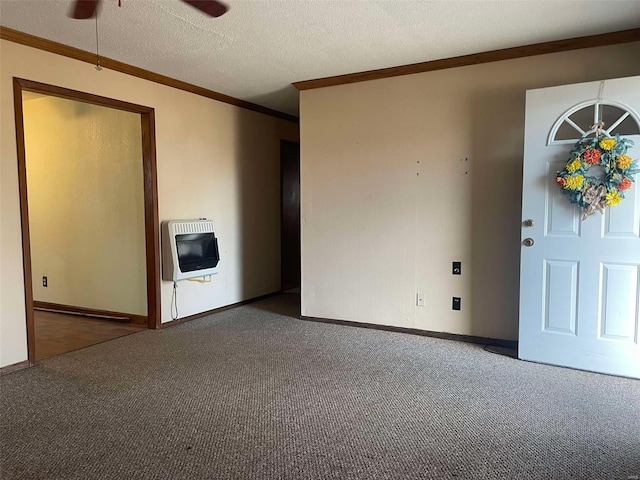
[300,42,640,339]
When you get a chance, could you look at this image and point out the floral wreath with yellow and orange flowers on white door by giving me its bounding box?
[556,123,640,220]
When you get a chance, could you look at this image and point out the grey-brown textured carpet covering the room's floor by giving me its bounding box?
[0,295,640,480]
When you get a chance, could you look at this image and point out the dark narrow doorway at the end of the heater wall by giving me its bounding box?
[280,140,300,290]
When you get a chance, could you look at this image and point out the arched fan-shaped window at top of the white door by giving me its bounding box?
[547,100,640,145]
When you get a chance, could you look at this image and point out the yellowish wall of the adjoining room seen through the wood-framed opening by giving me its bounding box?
[23,92,147,315]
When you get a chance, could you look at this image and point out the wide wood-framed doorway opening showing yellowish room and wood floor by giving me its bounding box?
[13,78,160,364]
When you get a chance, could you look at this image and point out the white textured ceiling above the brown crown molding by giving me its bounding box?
[0,0,640,115]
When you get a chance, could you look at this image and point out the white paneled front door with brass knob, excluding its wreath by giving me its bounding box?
[518,77,640,378]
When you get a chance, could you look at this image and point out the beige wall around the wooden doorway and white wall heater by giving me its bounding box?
[0,40,298,366]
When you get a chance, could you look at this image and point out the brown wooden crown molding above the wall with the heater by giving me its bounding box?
[0,26,299,123]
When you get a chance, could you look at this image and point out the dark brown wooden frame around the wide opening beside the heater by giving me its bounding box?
[13,77,161,364]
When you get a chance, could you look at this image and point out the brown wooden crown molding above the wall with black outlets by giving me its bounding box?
[293,28,640,90]
